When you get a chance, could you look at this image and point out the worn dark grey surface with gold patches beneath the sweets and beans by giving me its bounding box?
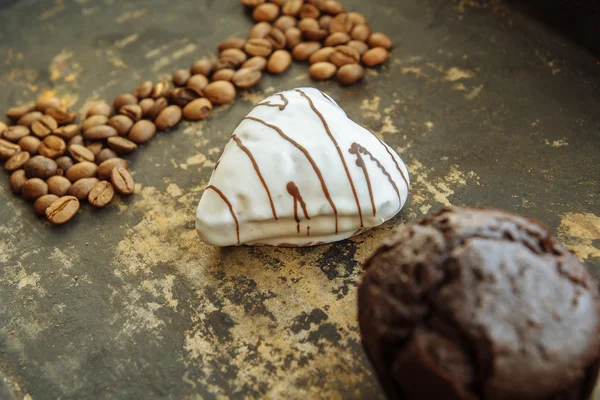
[0,0,600,399]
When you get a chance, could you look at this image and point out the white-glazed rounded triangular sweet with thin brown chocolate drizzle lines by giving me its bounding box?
[196,88,410,246]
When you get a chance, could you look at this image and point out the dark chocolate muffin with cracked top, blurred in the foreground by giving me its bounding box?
[358,208,600,400]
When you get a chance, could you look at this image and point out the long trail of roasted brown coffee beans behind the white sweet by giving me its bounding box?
[0,0,392,225]
